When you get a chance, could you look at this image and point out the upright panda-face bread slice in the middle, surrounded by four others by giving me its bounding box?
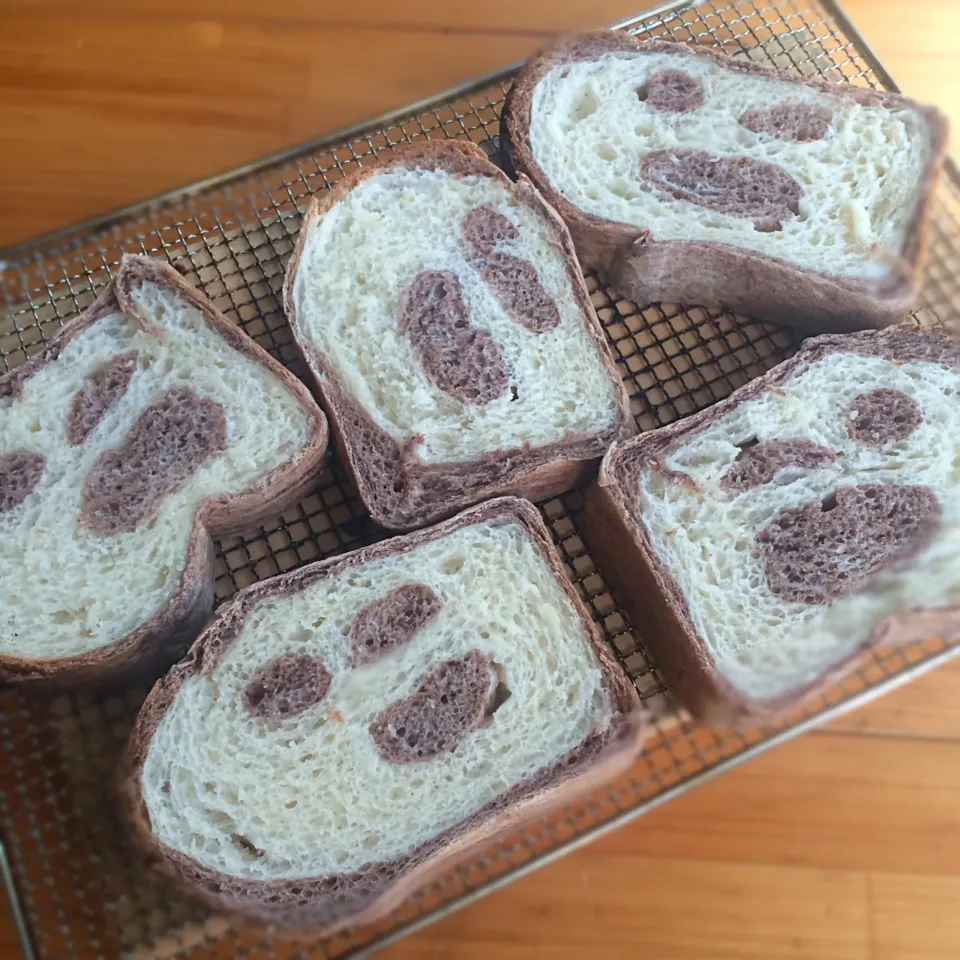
[284,141,634,529]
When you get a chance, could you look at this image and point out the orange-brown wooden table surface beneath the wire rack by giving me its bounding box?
[0,0,960,960]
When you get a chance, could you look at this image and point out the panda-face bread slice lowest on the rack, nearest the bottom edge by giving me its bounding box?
[121,498,643,932]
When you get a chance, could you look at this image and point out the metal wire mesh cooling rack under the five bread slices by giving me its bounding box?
[0,0,960,960]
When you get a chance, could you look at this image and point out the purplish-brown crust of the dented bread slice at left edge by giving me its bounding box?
[0,256,327,687]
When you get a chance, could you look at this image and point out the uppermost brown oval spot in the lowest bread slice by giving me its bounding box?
[350,583,443,667]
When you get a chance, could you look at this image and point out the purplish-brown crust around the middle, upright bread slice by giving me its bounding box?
[284,140,636,530]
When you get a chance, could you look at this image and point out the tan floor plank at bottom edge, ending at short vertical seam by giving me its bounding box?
[379,849,870,960]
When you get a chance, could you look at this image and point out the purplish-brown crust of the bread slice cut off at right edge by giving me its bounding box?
[581,329,960,725]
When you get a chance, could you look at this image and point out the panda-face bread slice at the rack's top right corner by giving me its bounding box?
[501,32,947,332]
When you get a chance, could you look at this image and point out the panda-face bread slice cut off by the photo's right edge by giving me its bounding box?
[583,329,960,722]
